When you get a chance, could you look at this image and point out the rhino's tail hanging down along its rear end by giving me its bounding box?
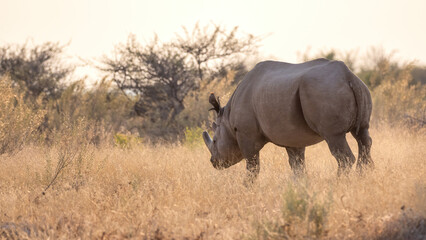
[348,71,371,135]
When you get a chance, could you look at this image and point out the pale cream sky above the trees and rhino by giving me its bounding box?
[0,0,426,80]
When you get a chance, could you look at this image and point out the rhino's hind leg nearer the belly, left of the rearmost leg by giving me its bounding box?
[325,133,355,176]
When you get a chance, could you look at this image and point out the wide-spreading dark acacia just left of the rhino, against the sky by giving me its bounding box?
[101,24,259,134]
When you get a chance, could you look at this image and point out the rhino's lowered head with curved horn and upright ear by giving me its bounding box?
[203,93,243,169]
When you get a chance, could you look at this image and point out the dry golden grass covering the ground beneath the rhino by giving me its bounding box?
[0,128,426,239]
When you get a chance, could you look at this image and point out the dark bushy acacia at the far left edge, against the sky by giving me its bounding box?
[0,42,72,98]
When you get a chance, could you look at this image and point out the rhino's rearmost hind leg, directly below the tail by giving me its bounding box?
[351,128,374,173]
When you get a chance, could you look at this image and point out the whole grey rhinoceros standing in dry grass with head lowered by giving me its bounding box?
[203,59,373,179]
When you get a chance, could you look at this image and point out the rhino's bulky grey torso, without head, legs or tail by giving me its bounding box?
[230,59,356,147]
